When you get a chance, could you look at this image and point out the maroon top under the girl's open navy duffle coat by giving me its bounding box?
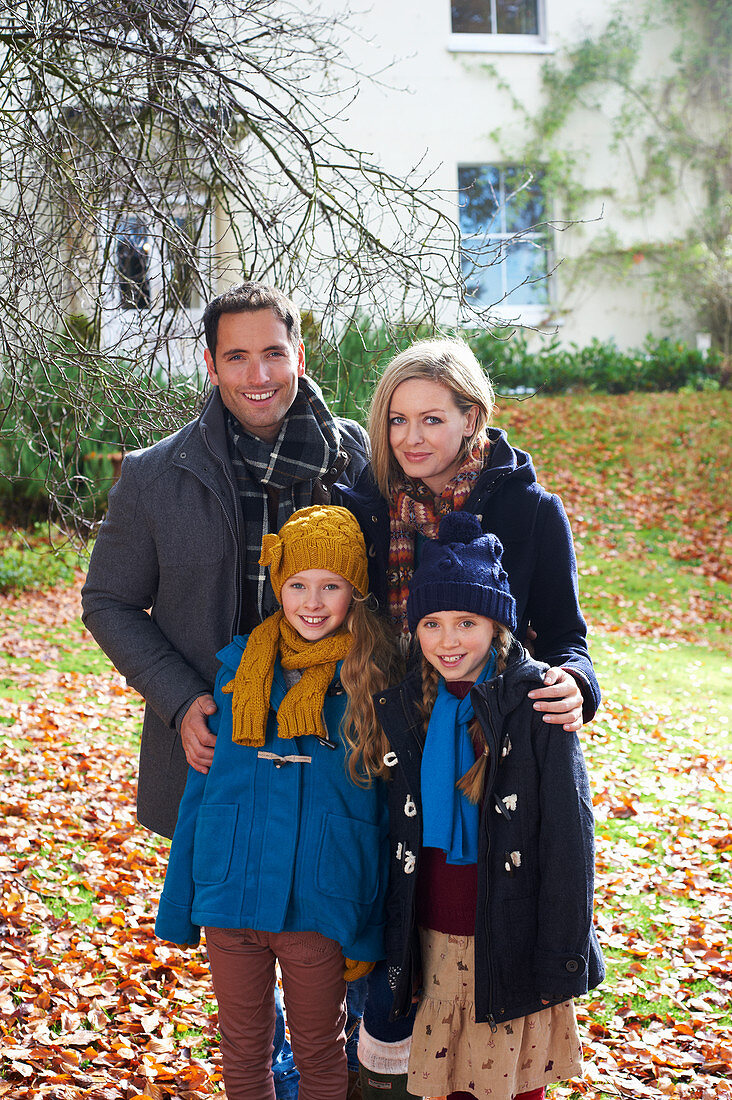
[417,680,482,936]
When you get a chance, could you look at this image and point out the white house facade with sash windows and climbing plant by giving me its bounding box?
[82,0,713,363]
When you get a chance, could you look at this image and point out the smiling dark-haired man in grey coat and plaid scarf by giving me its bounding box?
[81,283,369,1098]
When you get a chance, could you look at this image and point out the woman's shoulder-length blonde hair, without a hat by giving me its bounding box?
[369,340,494,499]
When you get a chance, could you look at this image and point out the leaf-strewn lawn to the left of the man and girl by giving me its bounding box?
[0,585,220,1100]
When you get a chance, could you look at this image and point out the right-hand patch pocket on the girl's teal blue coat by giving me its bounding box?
[315,814,381,905]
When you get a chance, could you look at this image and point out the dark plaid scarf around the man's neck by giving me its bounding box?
[227,377,340,631]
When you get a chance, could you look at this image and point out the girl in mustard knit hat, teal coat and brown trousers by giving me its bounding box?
[155,506,397,1100]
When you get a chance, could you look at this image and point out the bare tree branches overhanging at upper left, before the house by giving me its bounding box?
[0,0,508,530]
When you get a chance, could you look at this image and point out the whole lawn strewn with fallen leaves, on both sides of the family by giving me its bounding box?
[0,395,732,1100]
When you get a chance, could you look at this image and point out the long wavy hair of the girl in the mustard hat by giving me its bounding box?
[340,592,404,787]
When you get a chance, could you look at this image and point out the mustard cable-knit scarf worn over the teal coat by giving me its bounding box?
[222,611,352,748]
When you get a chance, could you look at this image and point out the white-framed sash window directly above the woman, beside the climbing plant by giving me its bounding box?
[458,164,549,318]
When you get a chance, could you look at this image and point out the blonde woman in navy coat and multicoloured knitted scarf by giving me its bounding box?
[339,340,600,1100]
